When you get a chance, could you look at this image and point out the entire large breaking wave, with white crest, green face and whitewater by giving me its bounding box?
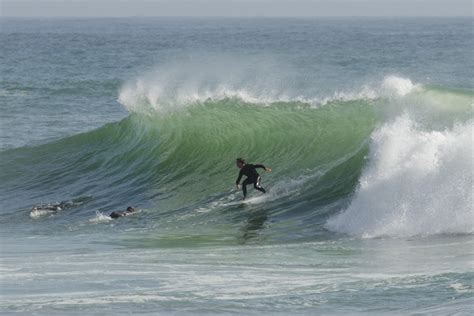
[0,67,473,241]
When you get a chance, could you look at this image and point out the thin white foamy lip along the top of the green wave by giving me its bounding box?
[118,76,414,113]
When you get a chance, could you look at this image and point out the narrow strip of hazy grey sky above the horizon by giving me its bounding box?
[0,0,473,17]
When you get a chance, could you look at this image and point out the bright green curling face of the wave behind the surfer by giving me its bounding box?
[148,100,375,207]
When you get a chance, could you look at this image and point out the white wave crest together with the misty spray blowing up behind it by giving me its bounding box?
[118,59,421,114]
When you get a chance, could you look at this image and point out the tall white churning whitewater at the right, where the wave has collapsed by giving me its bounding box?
[327,114,474,237]
